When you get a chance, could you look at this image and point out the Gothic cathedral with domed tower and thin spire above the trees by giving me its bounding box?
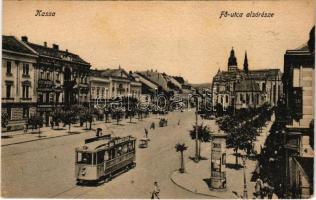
[211,49,283,110]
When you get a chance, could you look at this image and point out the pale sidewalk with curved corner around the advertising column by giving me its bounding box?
[171,115,274,199]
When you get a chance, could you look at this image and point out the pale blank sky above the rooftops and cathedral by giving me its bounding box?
[2,0,315,83]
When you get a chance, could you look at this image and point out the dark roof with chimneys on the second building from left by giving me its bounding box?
[26,42,89,64]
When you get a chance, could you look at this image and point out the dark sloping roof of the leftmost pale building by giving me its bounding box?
[2,35,36,55]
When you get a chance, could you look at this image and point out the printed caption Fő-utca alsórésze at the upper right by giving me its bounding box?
[219,11,274,19]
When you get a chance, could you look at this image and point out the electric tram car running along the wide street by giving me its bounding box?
[75,135,136,184]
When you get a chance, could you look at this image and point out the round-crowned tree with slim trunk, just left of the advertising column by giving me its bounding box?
[190,123,211,160]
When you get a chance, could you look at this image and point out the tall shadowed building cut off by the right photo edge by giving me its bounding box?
[283,27,315,198]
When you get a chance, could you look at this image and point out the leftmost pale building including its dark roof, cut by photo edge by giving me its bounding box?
[1,36,38,131]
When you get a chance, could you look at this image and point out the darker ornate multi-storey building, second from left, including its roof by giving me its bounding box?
[22,36,90,126]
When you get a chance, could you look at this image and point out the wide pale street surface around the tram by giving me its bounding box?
[1,111,213,198]
